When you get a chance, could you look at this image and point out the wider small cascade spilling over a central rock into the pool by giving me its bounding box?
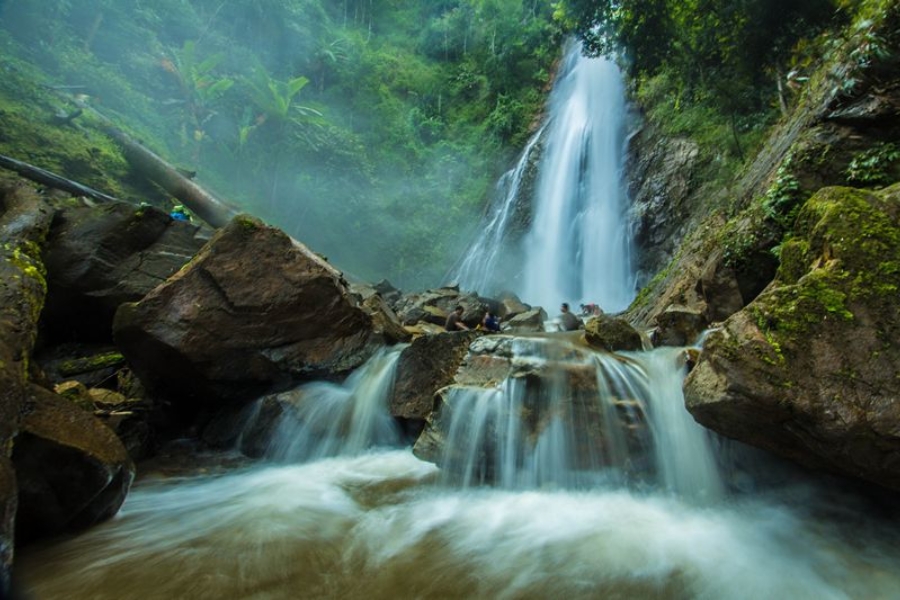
[435,336,722,501]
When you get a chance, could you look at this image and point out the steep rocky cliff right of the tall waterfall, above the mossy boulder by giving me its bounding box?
[628,8,900,327]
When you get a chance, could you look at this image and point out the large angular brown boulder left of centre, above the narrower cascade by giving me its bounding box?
[113,216,392,407]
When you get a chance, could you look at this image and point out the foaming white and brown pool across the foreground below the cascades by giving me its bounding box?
[17,450,900,600]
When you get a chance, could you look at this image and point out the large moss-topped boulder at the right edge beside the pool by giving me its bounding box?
[685,185,900,490]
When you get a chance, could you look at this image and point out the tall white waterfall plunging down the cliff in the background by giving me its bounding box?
[456,43,635,312]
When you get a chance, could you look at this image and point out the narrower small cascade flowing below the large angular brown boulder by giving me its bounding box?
[241,349,400,462]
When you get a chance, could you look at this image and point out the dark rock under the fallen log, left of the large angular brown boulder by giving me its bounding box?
[42,199,205,341]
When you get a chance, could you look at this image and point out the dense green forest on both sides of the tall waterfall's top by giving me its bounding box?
[0,0,892,289]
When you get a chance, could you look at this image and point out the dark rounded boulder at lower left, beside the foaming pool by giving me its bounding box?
[12,385,134,544]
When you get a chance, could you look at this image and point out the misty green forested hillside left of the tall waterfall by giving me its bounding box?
[0,0,558,290]
